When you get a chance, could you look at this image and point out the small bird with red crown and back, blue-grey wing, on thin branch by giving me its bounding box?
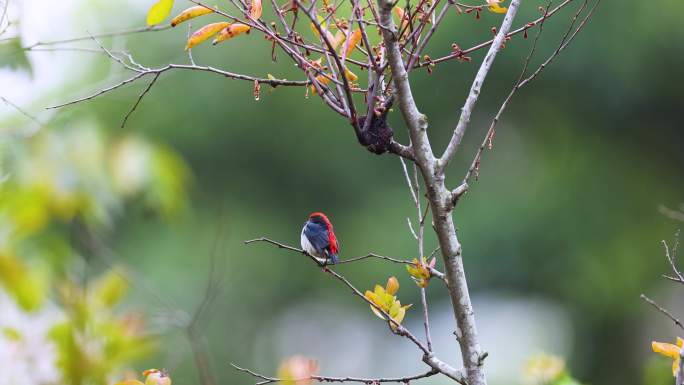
[301,213,339,265]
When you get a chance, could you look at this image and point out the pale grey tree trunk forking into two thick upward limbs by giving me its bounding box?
[377,0,520,385]
